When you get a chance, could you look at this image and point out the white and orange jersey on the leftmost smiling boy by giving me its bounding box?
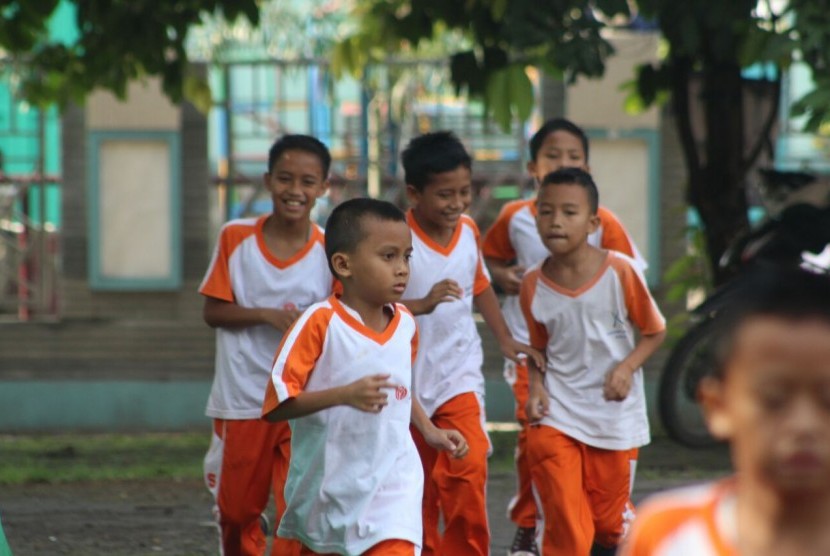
[199,216,333,419]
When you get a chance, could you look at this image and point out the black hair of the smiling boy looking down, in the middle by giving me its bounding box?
[401,131,473,191]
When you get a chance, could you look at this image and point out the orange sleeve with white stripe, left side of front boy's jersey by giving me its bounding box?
[262,307,333,415]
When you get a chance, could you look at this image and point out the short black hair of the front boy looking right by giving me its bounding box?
[326,197,406,277]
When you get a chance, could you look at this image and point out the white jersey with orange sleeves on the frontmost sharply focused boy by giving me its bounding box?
[262,296,424,554]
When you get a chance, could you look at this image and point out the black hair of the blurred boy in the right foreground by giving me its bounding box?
[713,263,830,378]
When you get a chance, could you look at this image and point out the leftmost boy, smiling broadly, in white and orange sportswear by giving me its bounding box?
[199,135,333,556]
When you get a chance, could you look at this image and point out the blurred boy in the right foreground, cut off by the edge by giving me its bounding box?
[620,268,830,556]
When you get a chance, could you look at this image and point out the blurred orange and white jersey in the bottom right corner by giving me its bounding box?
[619,480,738,556]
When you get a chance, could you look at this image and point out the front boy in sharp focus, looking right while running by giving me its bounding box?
[262,199,467,556]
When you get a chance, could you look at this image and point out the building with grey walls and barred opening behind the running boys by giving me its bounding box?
[0,26,808,433]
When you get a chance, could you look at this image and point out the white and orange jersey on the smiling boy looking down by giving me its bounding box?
[403,211,490,415]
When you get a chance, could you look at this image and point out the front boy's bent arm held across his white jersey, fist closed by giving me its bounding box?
[264,375,395,421]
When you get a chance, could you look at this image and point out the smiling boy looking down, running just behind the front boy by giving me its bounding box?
[401,132,540,556]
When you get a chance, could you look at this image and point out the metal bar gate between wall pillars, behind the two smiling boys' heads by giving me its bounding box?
[210,60,526,228]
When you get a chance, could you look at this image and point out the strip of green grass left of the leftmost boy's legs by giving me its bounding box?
[0,432,210,485]
